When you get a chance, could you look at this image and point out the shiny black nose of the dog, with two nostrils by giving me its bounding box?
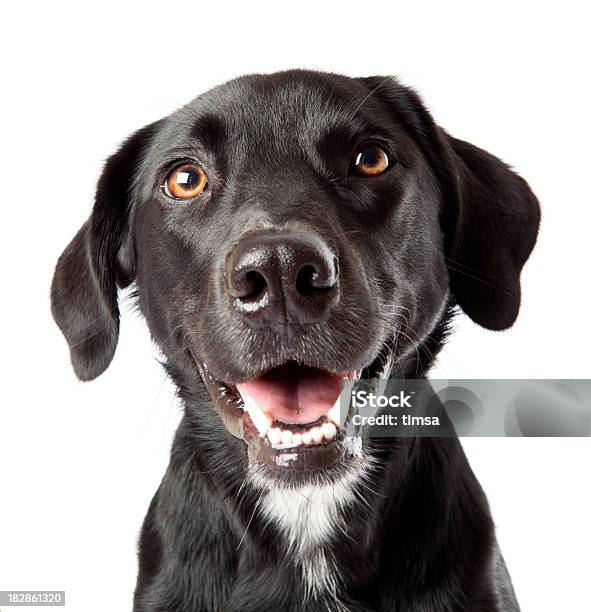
[226,233,339,325]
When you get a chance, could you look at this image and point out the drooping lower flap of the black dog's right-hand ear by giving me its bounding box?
[443,135,540,330]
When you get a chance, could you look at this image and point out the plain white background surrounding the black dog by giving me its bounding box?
[0,0,591,612]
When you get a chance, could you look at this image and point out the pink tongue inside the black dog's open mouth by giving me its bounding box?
[236,364,343,424]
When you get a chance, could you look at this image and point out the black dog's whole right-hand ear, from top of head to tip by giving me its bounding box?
[361,77,540,330]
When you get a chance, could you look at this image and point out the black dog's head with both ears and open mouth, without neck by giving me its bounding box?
[52,71,539,472]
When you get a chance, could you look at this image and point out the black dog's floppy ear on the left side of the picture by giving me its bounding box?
[51,123,158,380]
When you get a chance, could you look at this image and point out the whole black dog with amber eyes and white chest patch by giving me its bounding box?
[52,71,540,612]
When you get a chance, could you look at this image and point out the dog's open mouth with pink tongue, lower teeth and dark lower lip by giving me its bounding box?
[197,361,360,471]
